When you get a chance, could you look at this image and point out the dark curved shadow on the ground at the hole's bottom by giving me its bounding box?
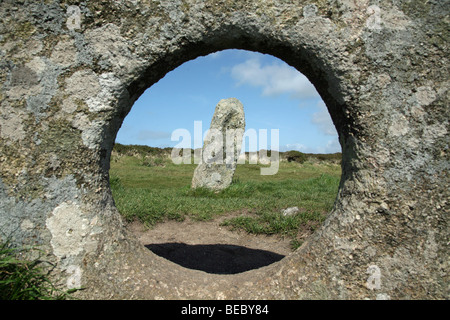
[146,243,284,274]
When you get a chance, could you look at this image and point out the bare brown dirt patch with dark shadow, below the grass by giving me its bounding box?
[128,216,292,274]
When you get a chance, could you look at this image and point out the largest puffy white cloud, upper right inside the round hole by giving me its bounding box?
[231,58,319,98]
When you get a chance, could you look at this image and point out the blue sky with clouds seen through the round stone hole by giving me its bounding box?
[116,49,341,153]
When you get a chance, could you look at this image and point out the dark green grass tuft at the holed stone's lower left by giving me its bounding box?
[0,243,76,300]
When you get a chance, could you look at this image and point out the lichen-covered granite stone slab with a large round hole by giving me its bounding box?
[0,0,449,299]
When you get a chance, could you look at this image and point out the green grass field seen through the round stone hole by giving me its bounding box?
[110,149,341,246]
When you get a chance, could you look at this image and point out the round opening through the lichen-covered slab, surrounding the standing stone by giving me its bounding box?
[110,50,341,274]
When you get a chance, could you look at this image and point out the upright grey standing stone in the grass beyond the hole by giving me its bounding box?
[192,98,245,190]
